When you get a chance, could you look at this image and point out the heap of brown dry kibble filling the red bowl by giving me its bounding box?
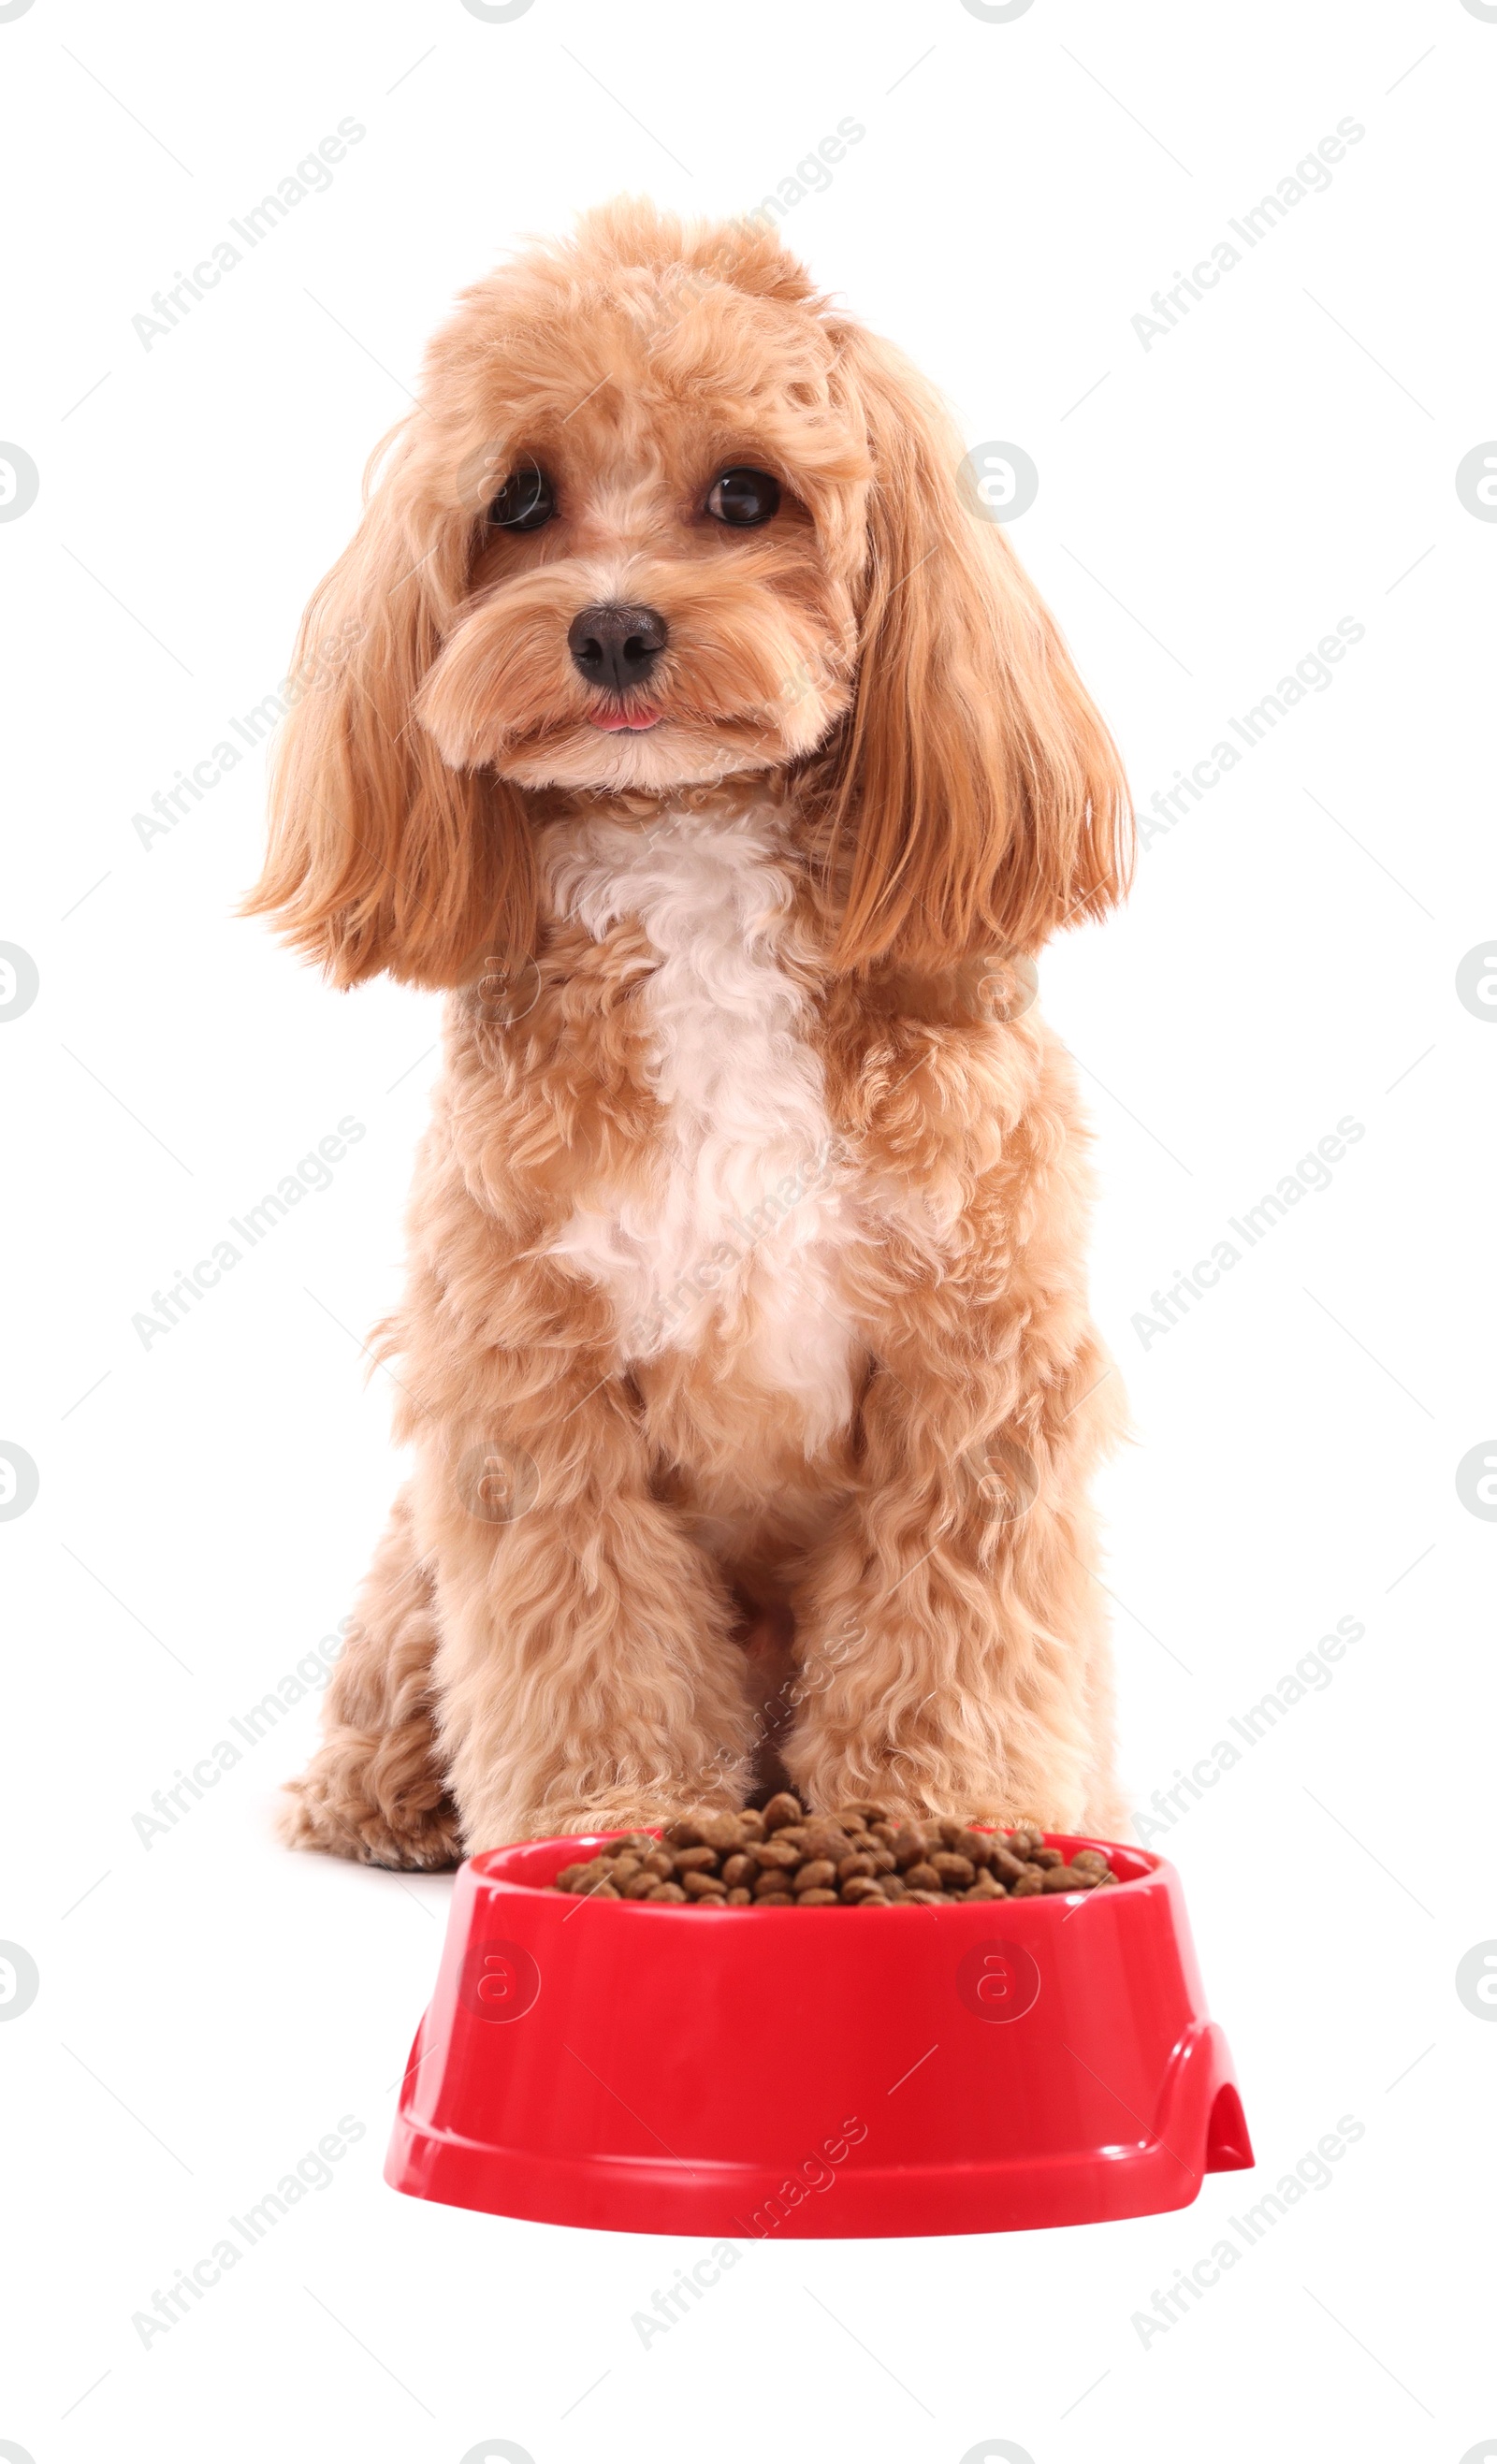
[550,1796,1117,1907]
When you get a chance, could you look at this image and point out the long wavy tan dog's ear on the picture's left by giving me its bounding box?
[244,428,535,986]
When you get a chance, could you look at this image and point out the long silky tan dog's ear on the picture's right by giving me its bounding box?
[809,326,1132,968]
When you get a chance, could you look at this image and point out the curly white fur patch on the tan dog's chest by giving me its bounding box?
[550,813,853,1444]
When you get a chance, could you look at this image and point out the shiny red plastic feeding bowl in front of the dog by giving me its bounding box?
[385,1834,1253,2238]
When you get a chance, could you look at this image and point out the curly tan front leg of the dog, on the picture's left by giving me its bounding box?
[419,1372,752,1853]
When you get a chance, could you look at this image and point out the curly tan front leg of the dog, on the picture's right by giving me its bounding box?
[782,1343,1120,1831]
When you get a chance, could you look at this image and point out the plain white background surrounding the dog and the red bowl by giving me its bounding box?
[0,0,1497,2464]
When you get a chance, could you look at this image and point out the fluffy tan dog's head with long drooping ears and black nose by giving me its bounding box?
[249,205,1129,983]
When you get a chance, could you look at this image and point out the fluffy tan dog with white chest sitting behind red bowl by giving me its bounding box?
[247,199,1132,1868]
